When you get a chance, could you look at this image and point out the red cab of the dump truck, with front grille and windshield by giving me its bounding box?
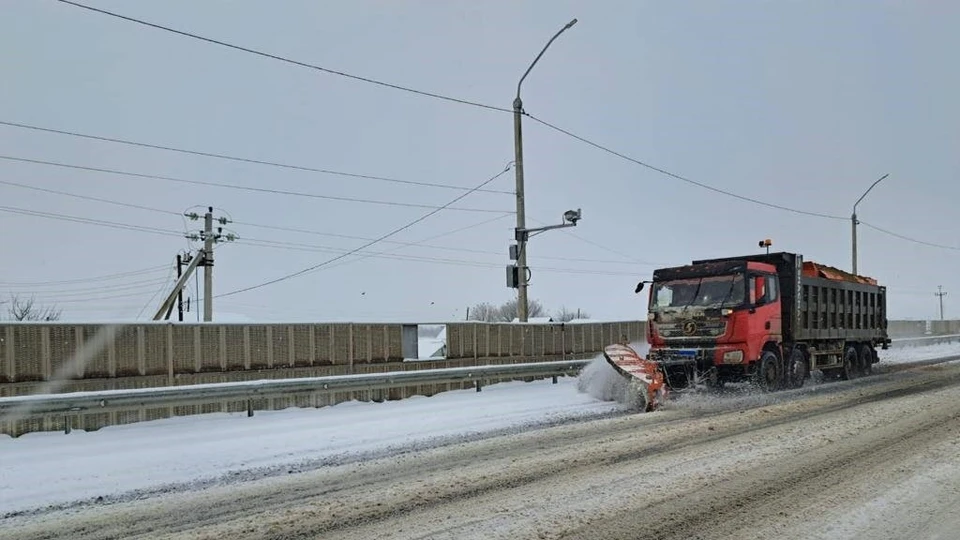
[640,261,782,388]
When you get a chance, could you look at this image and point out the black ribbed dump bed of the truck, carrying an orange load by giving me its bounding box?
[693,252,889,344]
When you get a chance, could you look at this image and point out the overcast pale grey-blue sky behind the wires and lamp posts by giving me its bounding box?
[0,0,960,321]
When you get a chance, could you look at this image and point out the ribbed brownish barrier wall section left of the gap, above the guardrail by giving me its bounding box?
[0,323,403,384]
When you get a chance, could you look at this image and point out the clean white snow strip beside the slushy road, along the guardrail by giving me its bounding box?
[0,343,960,517]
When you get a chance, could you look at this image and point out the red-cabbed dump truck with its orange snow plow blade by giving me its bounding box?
[606,253,890,409]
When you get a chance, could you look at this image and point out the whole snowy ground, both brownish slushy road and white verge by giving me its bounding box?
[0,345,960,539]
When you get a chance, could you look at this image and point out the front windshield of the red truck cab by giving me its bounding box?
[650,274,746,311]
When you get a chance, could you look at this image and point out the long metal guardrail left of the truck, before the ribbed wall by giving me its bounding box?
[0,360,591,420]
